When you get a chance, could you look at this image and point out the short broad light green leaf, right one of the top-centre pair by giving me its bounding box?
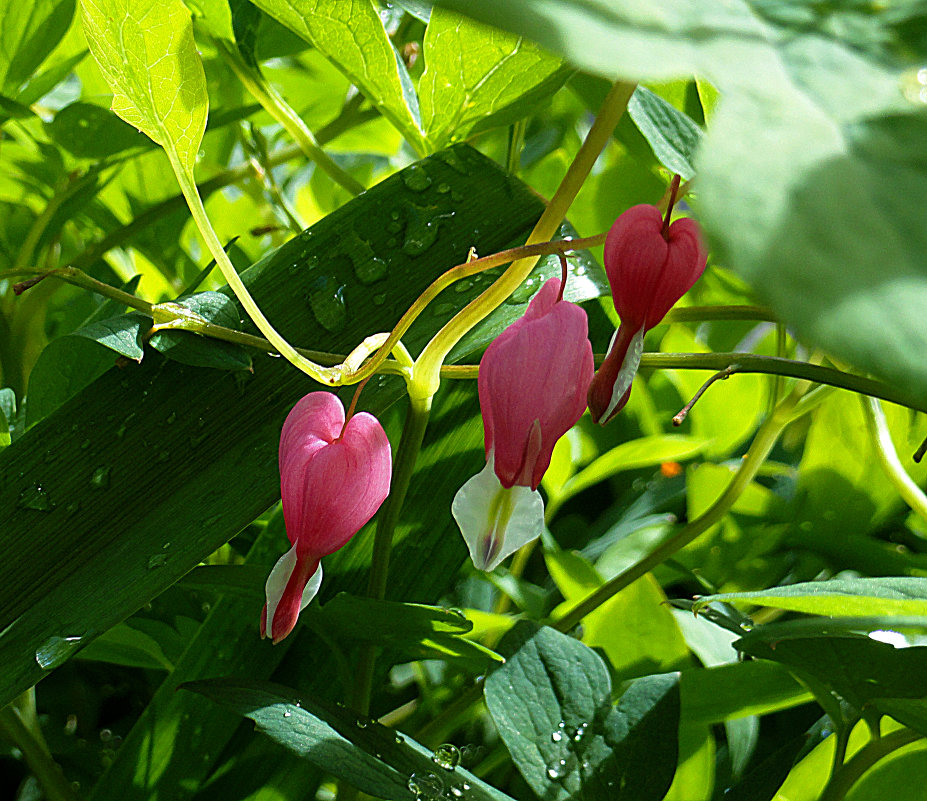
[418,8,569,149]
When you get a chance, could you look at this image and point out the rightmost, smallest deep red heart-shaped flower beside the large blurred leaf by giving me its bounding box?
[588,195,707,424]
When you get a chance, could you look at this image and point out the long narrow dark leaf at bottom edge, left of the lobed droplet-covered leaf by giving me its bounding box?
[183,679,510,801]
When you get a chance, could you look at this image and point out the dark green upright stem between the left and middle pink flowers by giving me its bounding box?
[351,398,431,715]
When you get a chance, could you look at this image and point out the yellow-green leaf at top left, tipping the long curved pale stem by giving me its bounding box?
[81,0,209,174]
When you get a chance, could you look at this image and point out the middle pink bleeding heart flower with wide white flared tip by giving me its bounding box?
[451,278,593,571]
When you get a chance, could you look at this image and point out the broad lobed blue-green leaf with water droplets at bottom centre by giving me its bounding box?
[485,622,679,801]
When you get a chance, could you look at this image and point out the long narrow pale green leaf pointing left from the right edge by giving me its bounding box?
[692,577,927,623]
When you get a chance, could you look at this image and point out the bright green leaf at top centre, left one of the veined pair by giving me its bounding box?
[243,0,425,152]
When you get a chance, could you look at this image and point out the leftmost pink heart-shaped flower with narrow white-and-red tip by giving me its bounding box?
[261,392,392,644]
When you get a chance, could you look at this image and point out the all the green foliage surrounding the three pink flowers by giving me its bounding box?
[0,0,927,801]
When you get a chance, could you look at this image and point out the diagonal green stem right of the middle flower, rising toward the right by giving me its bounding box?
[554,387,805,631]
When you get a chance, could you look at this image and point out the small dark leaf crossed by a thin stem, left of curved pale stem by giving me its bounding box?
[149,292,251,370]
